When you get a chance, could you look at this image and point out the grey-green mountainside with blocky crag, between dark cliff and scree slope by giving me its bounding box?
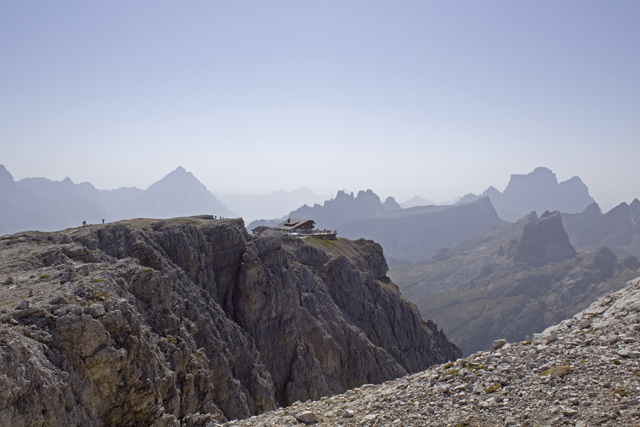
[389,211,640,354]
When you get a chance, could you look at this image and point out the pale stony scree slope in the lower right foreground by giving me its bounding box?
[226,278,640,427]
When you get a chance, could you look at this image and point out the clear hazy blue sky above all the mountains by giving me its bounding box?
[0,0,640,209]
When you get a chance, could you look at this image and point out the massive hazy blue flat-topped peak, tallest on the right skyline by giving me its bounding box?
[458,167,595,222]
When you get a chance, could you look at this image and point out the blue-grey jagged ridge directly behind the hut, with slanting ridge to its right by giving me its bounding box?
[248,190,504,265]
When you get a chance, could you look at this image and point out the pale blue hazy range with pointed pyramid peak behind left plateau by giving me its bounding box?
[0,165,237,235]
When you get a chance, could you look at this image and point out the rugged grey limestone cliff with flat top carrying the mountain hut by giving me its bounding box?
[0,218,459,426]
